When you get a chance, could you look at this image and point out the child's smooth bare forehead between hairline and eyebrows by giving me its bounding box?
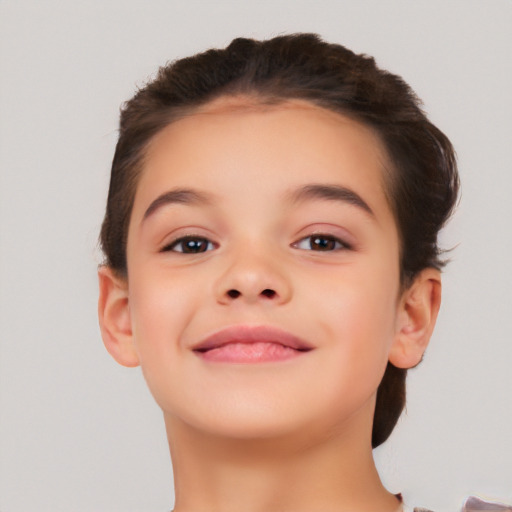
[134,97,389,223]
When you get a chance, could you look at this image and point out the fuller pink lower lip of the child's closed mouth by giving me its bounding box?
[196,342,306,363]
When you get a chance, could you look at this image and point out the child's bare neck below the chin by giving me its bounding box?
[166,410,399,512]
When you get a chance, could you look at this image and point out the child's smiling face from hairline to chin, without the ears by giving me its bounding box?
[123,101,399,438]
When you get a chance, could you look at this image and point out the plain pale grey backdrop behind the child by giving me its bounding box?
[0,0,512,512]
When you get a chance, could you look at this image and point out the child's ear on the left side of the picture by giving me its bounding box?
[98,266,139,366]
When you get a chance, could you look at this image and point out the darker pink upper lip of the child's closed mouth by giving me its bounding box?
[192,325,314,352]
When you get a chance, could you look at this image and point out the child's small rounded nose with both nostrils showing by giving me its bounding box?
[215,247,292,304]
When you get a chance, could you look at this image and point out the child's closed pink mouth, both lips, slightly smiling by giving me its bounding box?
[192,325,314,363]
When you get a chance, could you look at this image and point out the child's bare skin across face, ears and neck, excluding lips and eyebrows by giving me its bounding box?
[99,99,440,512]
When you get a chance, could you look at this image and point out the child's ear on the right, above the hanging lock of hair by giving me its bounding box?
[389,268,441,368]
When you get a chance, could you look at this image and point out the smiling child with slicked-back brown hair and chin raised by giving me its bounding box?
[99,34,508,512]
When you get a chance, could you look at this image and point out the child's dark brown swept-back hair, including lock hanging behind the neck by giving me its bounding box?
[100,34,459,447]
